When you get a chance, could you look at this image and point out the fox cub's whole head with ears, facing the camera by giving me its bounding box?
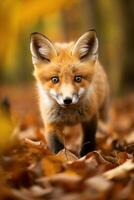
[30,30,98,107]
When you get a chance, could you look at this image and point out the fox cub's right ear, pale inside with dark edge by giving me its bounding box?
[72,30,98,60]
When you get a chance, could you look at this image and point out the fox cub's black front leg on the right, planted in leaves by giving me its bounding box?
[80,116,97,157]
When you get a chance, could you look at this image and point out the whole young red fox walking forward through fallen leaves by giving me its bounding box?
[30,30,109,156]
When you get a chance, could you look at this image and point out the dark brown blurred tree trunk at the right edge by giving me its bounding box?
[120,0,134,91]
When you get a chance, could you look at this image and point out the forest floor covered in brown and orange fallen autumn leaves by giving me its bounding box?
[0,83,134,200]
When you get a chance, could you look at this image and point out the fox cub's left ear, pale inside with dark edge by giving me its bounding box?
[30,32,57,64]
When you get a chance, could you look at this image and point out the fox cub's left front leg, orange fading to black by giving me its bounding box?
[45,124,64,153]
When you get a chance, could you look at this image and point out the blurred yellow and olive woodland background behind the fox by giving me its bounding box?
[0,0,134,117]
